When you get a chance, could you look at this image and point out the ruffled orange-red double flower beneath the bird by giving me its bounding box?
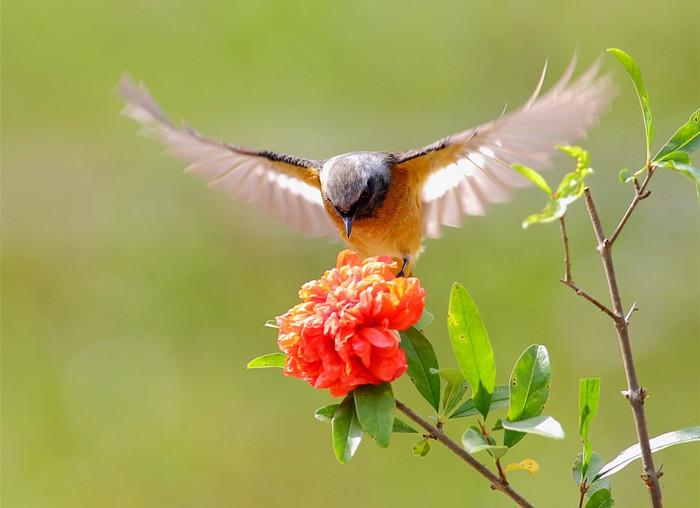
[277,250,425,396]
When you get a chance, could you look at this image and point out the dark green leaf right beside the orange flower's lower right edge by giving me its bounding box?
[401,328,440,411]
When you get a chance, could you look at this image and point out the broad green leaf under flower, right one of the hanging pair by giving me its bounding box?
[353,383,395,448]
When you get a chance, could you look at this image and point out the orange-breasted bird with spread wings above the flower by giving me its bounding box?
[118,57,613,276]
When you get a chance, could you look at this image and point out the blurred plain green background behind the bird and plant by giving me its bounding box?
[2,0,700,508]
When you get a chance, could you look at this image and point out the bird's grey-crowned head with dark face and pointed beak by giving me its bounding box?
[320,152,393,238]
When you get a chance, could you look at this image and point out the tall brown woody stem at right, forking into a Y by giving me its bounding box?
[584,187,662,508]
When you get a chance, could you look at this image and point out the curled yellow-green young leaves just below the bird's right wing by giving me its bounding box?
[511,146,593,228]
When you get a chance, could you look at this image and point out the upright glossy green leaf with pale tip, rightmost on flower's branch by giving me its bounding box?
[503,344,552,446]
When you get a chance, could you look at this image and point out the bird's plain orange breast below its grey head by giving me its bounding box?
[324,170,423,261]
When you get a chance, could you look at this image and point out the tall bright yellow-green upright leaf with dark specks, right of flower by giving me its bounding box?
[447,283,496,418]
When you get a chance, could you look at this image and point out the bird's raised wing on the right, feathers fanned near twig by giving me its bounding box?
[396,58,613,238]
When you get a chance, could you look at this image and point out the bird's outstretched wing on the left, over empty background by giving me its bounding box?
[119,75,338,237]
